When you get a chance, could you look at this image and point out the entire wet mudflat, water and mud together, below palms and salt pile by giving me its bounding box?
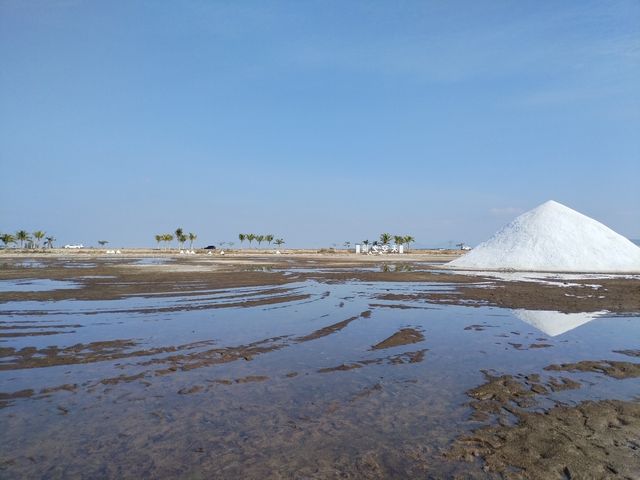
[0,258,640,478]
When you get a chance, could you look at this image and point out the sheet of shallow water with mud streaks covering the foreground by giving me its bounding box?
[0,266,640,478]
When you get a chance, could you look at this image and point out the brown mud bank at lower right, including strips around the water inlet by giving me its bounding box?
[446,360,640,480]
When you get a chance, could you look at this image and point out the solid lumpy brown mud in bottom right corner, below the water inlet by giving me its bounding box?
[447,400,640,479]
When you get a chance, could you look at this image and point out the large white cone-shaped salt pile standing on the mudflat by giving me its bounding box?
[448,200,640,272]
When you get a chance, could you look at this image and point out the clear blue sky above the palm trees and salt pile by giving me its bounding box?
[0,0,640,247]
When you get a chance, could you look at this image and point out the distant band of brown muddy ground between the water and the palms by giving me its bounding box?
[0,254,640,313]
